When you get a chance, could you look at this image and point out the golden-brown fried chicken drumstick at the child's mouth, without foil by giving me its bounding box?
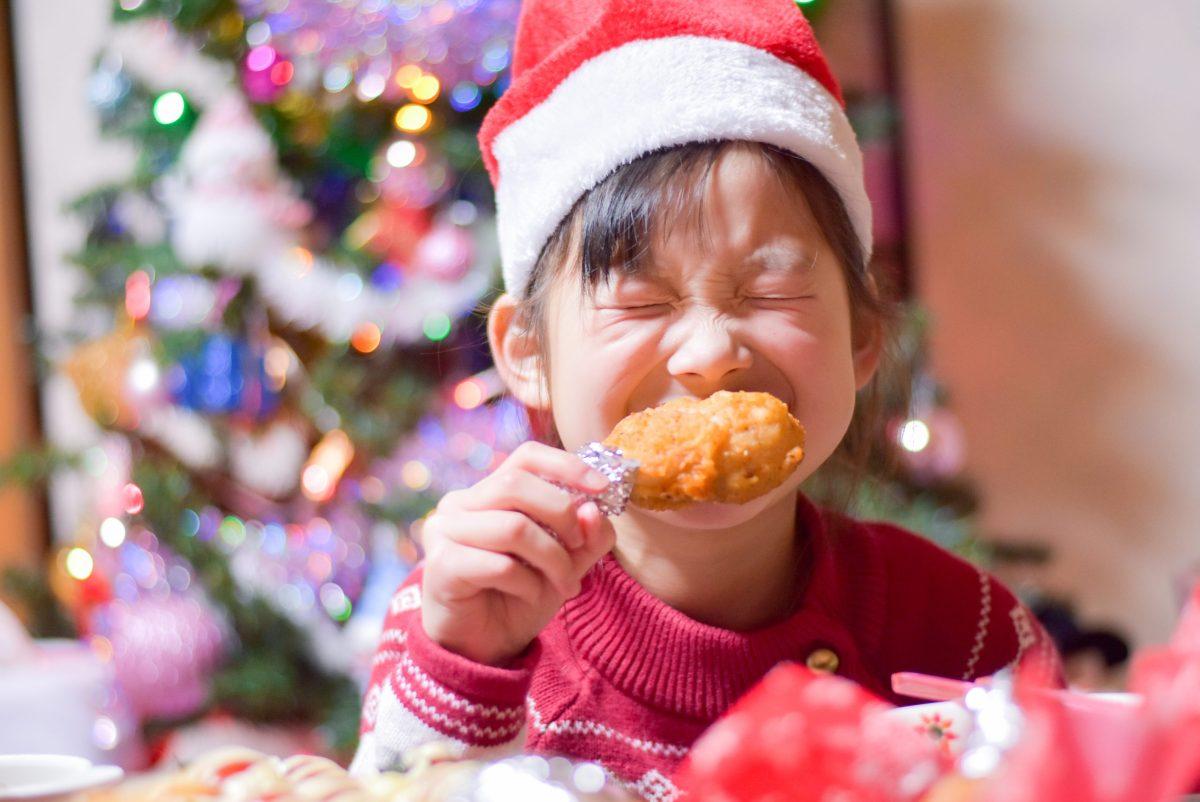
[605,390,804,510]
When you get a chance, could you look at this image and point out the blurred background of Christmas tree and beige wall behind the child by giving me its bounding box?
[0,0,1200,768]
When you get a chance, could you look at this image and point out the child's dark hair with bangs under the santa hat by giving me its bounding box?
[506,140,899,508]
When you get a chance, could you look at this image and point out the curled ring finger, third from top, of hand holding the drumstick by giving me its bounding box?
[439,510,578,598]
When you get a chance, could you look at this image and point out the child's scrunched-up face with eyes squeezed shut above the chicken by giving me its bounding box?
[499,148,878,525]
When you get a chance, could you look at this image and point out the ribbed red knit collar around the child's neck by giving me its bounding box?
[563,495,850,720]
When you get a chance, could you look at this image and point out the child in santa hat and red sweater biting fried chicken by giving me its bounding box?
[355,0,1055,800]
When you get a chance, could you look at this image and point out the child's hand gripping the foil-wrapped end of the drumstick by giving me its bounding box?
[421,443,614,665]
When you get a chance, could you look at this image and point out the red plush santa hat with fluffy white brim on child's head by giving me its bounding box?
[479,0,871,293]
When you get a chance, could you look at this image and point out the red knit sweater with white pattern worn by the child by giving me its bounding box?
[353,496,1057,802]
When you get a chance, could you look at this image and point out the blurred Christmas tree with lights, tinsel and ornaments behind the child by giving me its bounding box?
[0,0,993,768]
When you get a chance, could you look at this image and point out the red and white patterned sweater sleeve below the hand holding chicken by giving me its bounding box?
[350,568,540,774]
